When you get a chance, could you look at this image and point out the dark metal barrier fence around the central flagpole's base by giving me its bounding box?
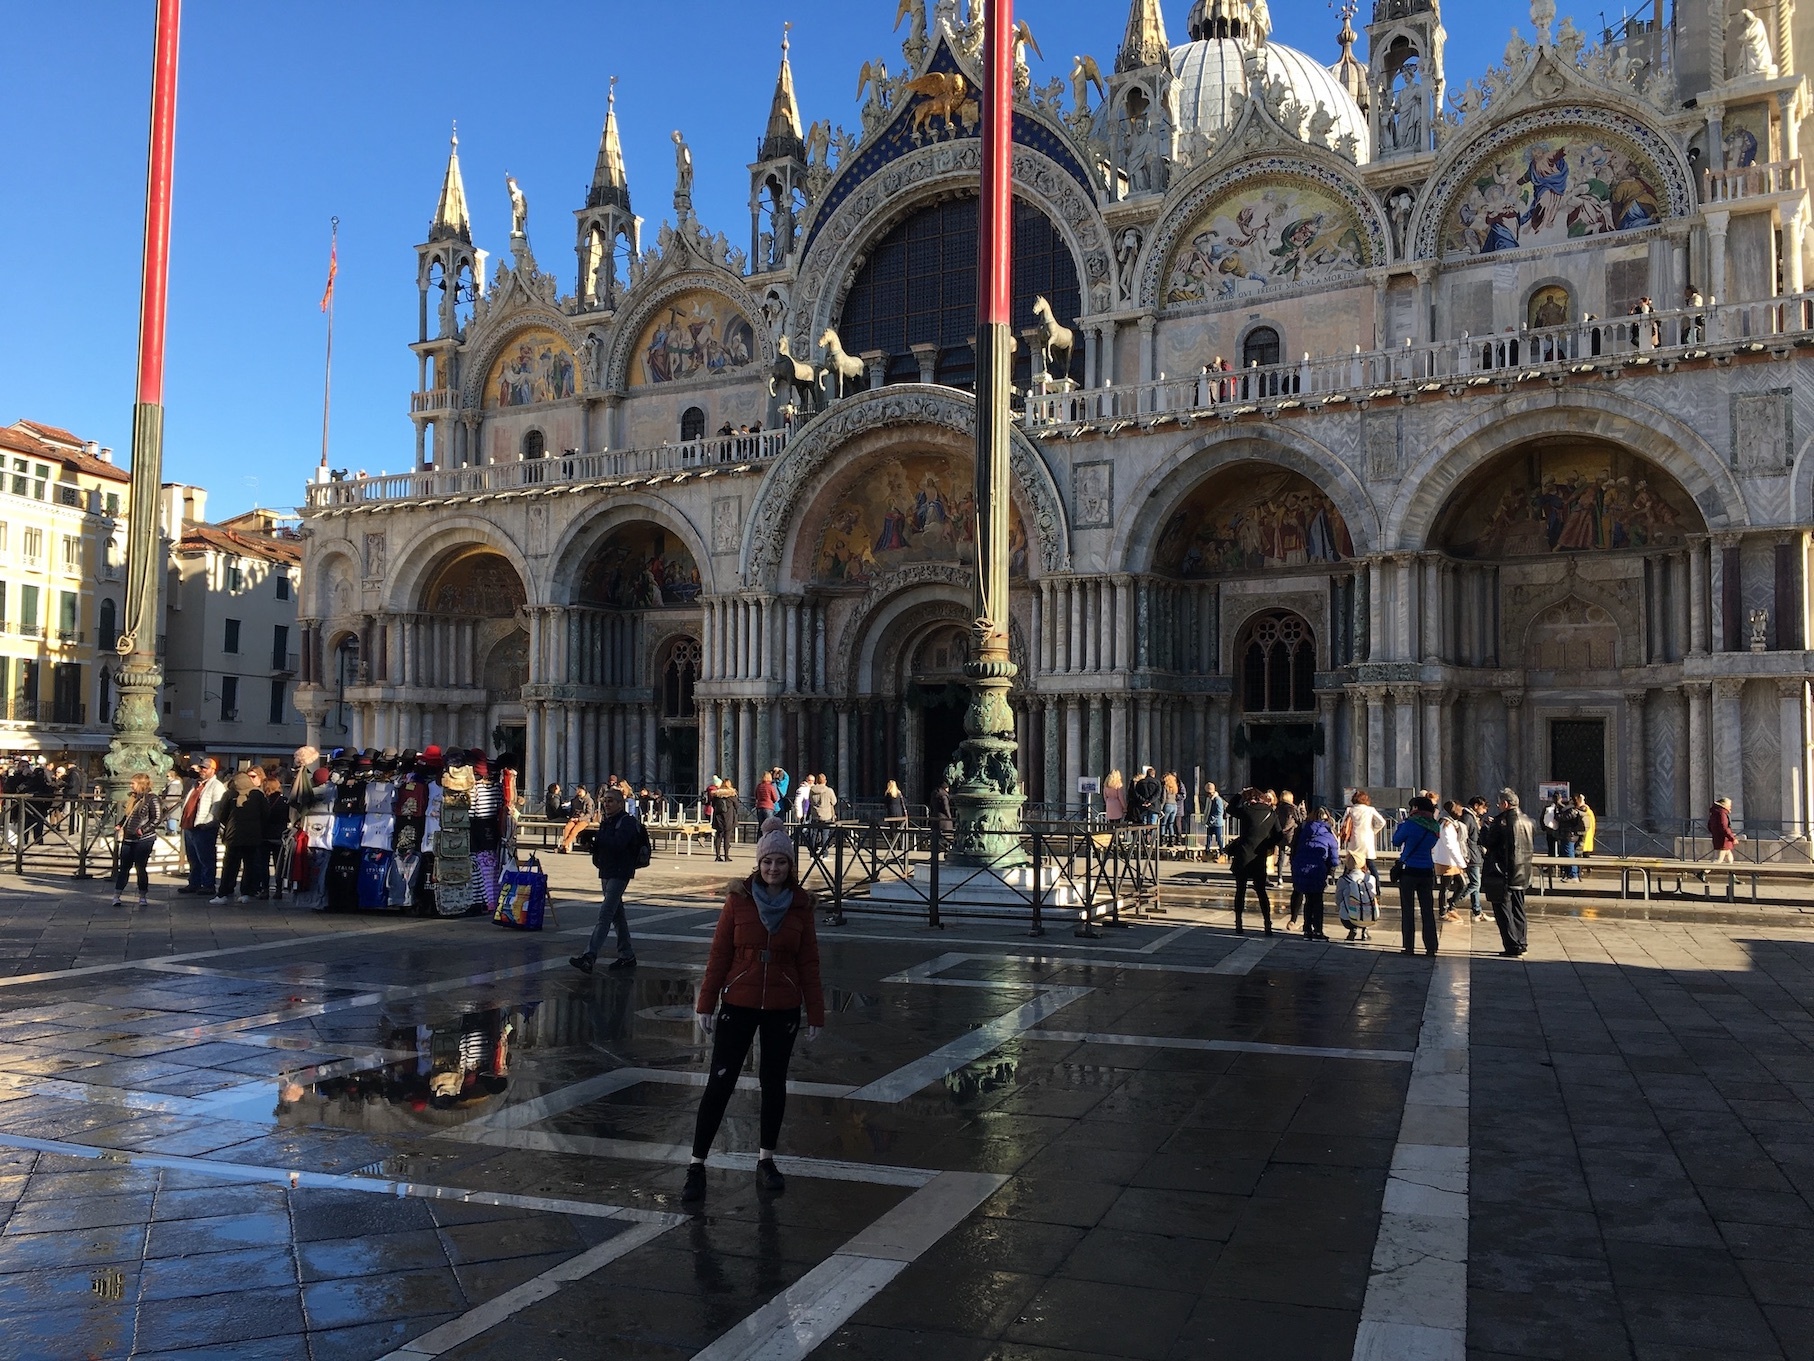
[789,818,1163,936]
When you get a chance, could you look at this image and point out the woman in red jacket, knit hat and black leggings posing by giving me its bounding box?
[680,818,825,1201]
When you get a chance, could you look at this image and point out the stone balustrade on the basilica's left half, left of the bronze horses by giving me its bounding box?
[305,430,787,510]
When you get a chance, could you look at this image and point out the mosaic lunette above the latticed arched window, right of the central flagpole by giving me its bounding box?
[1154,463,1355,579]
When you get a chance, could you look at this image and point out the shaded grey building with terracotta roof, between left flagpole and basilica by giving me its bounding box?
[158,483,303,764]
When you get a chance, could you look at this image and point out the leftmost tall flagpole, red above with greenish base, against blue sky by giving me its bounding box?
[107,0,181,800]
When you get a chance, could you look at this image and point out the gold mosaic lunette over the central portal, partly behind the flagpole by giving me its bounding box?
[805,450,1027,588]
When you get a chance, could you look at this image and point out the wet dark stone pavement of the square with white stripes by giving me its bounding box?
[0,866,1814,1361]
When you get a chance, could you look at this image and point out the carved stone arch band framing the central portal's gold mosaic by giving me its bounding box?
[744,383,1070,590]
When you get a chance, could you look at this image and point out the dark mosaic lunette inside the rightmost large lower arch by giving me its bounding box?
[1431,436,1707,561]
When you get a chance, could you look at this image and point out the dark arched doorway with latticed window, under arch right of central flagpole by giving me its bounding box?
[1235,610,1328,798]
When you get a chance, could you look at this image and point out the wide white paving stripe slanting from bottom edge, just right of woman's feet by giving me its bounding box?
[693,1172,1007,1361]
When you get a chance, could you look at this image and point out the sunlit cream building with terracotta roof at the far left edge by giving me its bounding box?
[0,421,131,764]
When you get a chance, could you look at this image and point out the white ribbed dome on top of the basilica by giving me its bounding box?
[1172,0,1371,162]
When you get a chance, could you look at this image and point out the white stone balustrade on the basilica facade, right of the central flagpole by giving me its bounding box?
[1025,292,1814,434]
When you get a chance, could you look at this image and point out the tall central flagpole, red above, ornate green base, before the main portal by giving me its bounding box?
[951,0,1027,871]
